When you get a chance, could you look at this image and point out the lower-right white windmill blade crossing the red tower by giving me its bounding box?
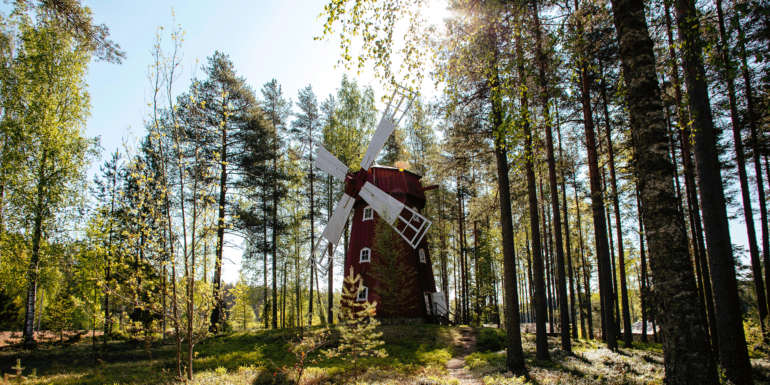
[358,182,433,248]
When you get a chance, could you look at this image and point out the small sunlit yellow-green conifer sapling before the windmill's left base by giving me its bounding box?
[325,267,388,380]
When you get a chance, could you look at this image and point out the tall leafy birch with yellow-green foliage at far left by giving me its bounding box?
[5,14,98,347]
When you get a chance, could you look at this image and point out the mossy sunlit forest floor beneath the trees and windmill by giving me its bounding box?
[0,325,770,385]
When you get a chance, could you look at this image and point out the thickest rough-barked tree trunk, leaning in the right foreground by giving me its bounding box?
[612,0,720,378]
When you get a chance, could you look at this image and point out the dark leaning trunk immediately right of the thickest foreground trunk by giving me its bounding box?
[672,0,752,385]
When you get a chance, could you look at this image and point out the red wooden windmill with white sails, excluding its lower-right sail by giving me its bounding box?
[311,86,447,320]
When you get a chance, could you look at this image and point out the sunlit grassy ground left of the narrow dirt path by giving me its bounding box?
[0,325,459,385]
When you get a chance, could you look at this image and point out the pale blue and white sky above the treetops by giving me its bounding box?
[0,0,761,282]
